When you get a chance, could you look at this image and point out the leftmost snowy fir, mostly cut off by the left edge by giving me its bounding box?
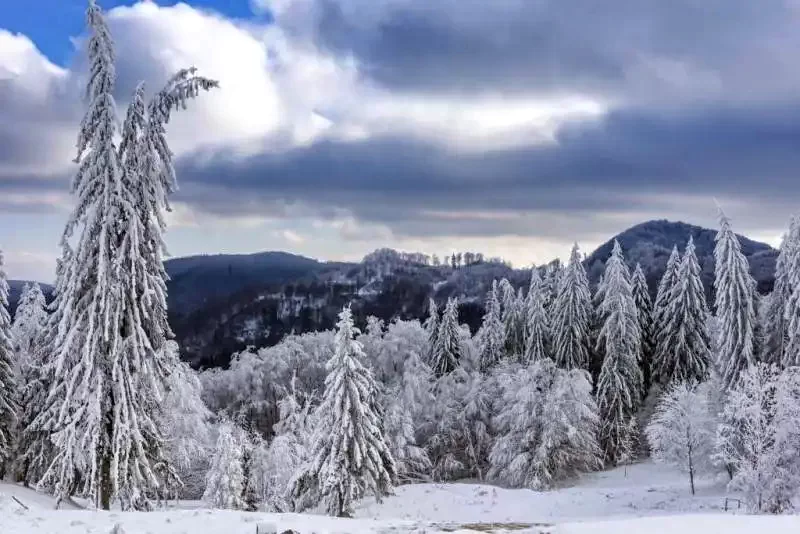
[0,250,17,479]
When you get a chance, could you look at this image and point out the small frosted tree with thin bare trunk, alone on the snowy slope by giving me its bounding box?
[645,382,716,495]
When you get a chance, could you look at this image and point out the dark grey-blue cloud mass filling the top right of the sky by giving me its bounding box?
[288,0,800,99]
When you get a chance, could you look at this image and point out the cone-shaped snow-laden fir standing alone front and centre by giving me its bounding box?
[291,307,396,517]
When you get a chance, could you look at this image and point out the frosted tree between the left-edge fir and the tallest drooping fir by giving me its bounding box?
[11,283,50,485]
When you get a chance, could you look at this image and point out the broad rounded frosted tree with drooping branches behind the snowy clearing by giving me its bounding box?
[489,359,602,490]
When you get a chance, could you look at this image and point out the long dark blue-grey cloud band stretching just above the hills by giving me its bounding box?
[180,100,800,241]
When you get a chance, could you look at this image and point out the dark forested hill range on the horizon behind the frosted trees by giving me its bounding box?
[4,220,777,367]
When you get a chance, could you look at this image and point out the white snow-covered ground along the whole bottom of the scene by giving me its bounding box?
[0,463,800,534]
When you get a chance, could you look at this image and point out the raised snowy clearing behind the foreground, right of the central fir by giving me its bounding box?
[356,462,737,523]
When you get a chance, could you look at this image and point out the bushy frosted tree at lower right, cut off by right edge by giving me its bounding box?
[717,363,800,513]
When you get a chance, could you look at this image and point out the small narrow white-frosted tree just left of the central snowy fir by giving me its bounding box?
[203,423,246,510]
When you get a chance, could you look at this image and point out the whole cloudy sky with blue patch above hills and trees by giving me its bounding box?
[0,0,800,281]
